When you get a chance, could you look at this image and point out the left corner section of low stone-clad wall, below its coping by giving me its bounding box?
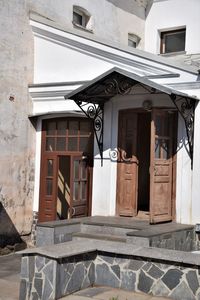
[19,253,96,300]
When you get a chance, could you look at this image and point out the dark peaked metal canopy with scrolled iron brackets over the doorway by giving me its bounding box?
[65,68,198,165]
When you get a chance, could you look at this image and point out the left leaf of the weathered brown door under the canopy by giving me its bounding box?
[117,111,138,216]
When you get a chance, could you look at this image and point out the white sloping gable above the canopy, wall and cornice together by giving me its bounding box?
[31,21,196,86]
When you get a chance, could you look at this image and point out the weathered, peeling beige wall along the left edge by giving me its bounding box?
[0,0,35,243]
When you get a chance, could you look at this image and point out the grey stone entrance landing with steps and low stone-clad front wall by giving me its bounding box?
[20,217,200,300]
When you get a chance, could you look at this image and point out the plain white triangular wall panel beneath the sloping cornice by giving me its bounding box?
[34,37,111,83]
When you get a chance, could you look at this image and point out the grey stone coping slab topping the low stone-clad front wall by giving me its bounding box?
[17,239,200,266]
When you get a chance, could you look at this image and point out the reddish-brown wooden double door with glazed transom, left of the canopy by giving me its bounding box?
[39,118,93,222]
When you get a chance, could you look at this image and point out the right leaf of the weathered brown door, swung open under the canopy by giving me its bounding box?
[150,110,176,223]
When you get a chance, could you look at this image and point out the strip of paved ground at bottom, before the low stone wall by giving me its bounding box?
[61,287,170,300]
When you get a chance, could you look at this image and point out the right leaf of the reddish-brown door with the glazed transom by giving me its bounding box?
[70,156,89,218]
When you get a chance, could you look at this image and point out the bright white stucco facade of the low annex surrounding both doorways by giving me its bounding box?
[32,22,198,223]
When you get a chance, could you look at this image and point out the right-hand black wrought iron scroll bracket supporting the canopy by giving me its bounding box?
[170,94,196,164]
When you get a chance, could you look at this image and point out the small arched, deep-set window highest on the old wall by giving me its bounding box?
[72,6,92,31]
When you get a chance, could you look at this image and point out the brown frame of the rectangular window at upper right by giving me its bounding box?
[160,27,186,55]
